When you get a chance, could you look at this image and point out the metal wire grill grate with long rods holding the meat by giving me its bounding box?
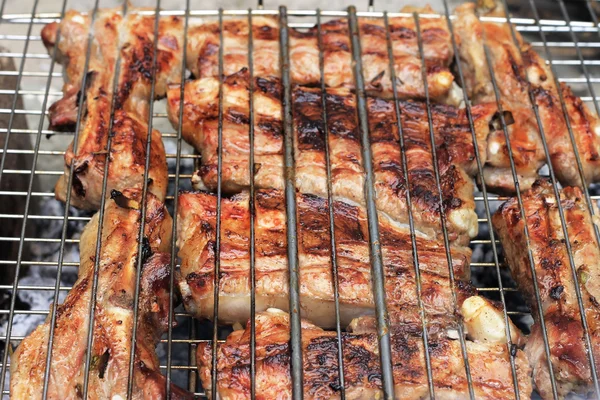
[0,0,600,399]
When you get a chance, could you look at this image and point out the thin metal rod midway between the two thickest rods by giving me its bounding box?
[317,9,346,400]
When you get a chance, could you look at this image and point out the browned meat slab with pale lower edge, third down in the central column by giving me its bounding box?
[178,190,473,327]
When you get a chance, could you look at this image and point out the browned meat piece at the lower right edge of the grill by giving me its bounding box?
[493,181,600,399]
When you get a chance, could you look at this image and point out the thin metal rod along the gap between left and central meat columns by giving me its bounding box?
[165,0,190,399]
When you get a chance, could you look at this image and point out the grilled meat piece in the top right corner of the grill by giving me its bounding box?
[455,4,600,192]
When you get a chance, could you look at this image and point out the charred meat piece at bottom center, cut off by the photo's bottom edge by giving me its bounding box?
[197,309,531,400]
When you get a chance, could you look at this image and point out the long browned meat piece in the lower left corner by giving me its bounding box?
[10,189,193,399]
